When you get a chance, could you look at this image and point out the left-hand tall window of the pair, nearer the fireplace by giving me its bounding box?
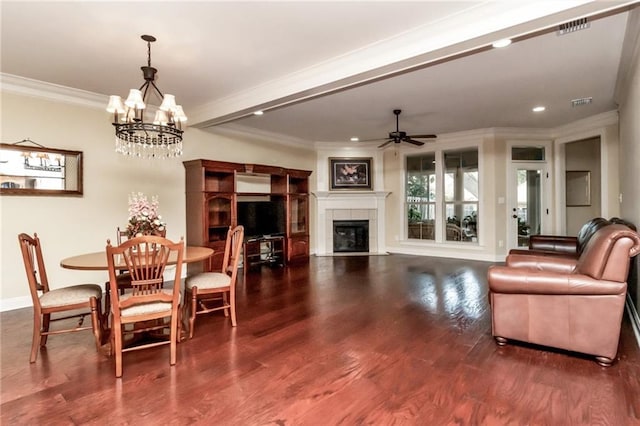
[406,153,436,240]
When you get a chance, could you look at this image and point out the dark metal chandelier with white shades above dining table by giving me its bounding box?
[107,35,187,158]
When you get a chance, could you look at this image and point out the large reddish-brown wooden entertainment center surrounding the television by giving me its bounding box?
[183,159,311,273]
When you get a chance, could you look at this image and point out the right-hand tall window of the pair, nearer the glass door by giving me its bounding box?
[444,148,480,242]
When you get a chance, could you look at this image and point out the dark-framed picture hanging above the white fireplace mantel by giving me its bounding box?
[329,157,373,191]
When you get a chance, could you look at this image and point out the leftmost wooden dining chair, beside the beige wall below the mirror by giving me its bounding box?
[18,233,102,362]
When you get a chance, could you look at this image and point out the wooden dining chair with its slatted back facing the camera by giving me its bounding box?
[107,235,184,377]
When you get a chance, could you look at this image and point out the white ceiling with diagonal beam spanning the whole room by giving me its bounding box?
[0,0,638,143]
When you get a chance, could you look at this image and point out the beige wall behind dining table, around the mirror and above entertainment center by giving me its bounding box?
[0,92,315,309]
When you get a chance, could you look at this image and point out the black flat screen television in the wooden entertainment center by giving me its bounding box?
[238,199,286,240]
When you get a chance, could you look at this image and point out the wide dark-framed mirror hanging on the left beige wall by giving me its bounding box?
[0,140,82,196]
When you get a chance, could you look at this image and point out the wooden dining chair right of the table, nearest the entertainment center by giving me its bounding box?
[183,225,244,338]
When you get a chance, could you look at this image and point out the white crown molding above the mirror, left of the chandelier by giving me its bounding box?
[0,73,109,109]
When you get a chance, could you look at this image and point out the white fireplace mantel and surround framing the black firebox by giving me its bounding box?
[312,191,391,256]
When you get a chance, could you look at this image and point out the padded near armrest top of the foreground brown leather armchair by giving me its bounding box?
[488,266,627,296]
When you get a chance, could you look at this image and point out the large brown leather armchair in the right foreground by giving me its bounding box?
[488,224,640,366]
